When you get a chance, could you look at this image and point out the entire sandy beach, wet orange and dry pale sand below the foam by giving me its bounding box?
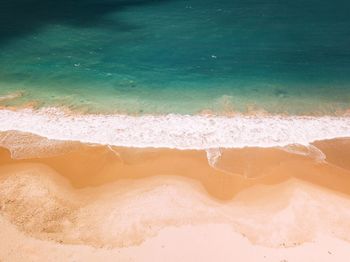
[0,132,350,261]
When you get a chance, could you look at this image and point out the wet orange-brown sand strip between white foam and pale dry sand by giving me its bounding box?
[0,132,350,200]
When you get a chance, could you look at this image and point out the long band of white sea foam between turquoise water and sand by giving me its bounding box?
[0,108,350,149]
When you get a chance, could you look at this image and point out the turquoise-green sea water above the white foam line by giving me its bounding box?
[0,0,350,114]
